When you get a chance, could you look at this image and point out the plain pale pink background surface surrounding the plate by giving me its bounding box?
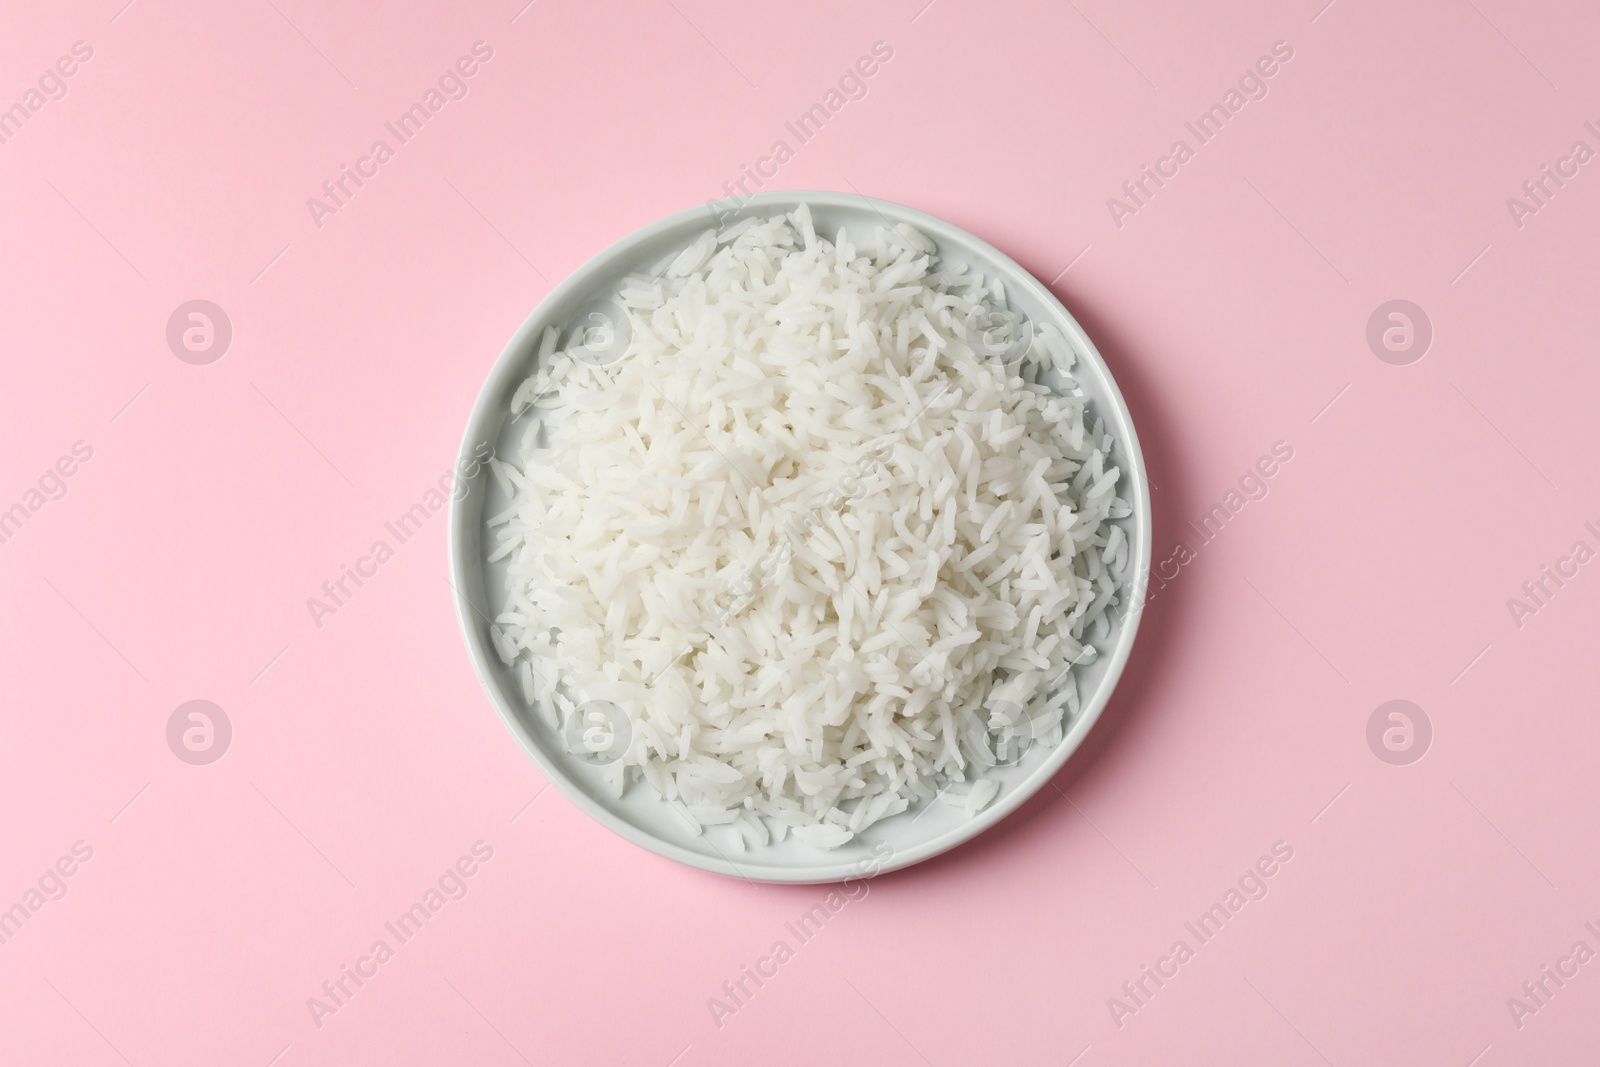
[0,0,1600,1067]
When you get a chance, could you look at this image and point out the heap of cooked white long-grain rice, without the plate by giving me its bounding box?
[490,206,1130,849]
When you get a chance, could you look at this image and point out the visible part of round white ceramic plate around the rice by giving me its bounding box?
[450,192,1150,883]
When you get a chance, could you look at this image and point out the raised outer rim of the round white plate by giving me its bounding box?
[446,189,1152,885]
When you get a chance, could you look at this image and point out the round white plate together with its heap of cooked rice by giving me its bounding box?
[450,192,1150,883]
